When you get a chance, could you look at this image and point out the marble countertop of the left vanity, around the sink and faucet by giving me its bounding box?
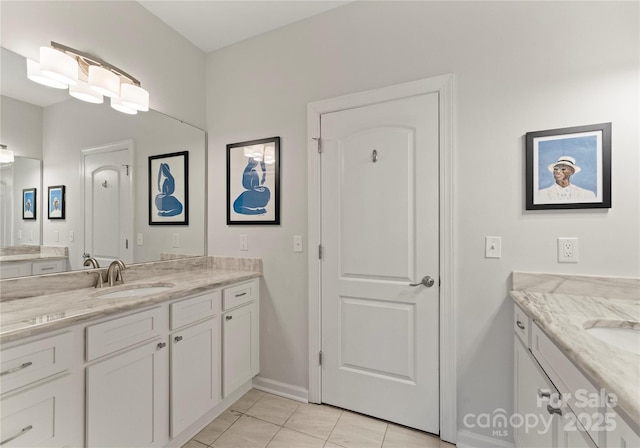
[0,267,262,344]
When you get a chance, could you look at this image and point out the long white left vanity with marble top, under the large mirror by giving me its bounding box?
[0,257,261,447]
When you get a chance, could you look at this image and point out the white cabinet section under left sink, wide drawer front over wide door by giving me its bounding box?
[85,307,169,448]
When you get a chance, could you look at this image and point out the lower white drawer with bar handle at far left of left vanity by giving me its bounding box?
[0,375,75,448]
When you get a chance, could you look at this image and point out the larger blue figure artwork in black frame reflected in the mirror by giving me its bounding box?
[149,151,189,225]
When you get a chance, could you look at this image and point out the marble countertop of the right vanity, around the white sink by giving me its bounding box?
[510,273,640,422]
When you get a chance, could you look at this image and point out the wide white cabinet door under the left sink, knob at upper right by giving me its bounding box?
[86,340,169,448]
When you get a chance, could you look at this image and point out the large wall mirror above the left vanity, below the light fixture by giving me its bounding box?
[0,48,207,270]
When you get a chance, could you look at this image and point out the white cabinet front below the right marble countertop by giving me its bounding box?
[514,305,640,448]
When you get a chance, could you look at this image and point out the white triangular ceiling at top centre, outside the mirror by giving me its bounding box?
[138,0,349,53]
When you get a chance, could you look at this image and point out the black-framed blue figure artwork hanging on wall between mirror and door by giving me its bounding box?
[227,137,280,225]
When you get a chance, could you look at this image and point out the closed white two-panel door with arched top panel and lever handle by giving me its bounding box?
[320,93,439,434]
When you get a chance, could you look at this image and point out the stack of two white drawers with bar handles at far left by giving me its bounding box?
[0,332,82,448]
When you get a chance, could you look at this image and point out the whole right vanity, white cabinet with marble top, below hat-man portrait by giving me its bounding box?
[510,272,640,448]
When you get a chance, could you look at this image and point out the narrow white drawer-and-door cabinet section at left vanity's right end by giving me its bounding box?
[222,279,260,397]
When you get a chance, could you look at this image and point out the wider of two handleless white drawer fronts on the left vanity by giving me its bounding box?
[86,308,166,361]
